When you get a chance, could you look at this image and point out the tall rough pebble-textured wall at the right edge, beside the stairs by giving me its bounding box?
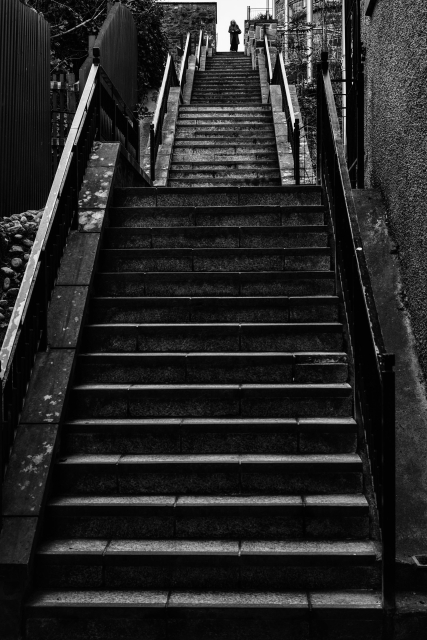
[362,0,427,377]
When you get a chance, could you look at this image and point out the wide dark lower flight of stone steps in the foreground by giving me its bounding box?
[26,187,382,640]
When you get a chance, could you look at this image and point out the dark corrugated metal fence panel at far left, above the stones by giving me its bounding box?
[0,0,51,217]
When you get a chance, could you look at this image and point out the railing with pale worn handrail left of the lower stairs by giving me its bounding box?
[0,60,139,516]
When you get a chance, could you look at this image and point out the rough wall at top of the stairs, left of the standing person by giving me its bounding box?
[162,2,217,53]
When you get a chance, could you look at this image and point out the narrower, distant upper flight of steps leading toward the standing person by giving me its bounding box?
[169,53,281,187]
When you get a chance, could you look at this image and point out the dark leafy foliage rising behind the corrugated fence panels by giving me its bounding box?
[27,0,169,105]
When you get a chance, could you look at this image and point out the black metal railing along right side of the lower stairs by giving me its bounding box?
[317,53,395,610]
